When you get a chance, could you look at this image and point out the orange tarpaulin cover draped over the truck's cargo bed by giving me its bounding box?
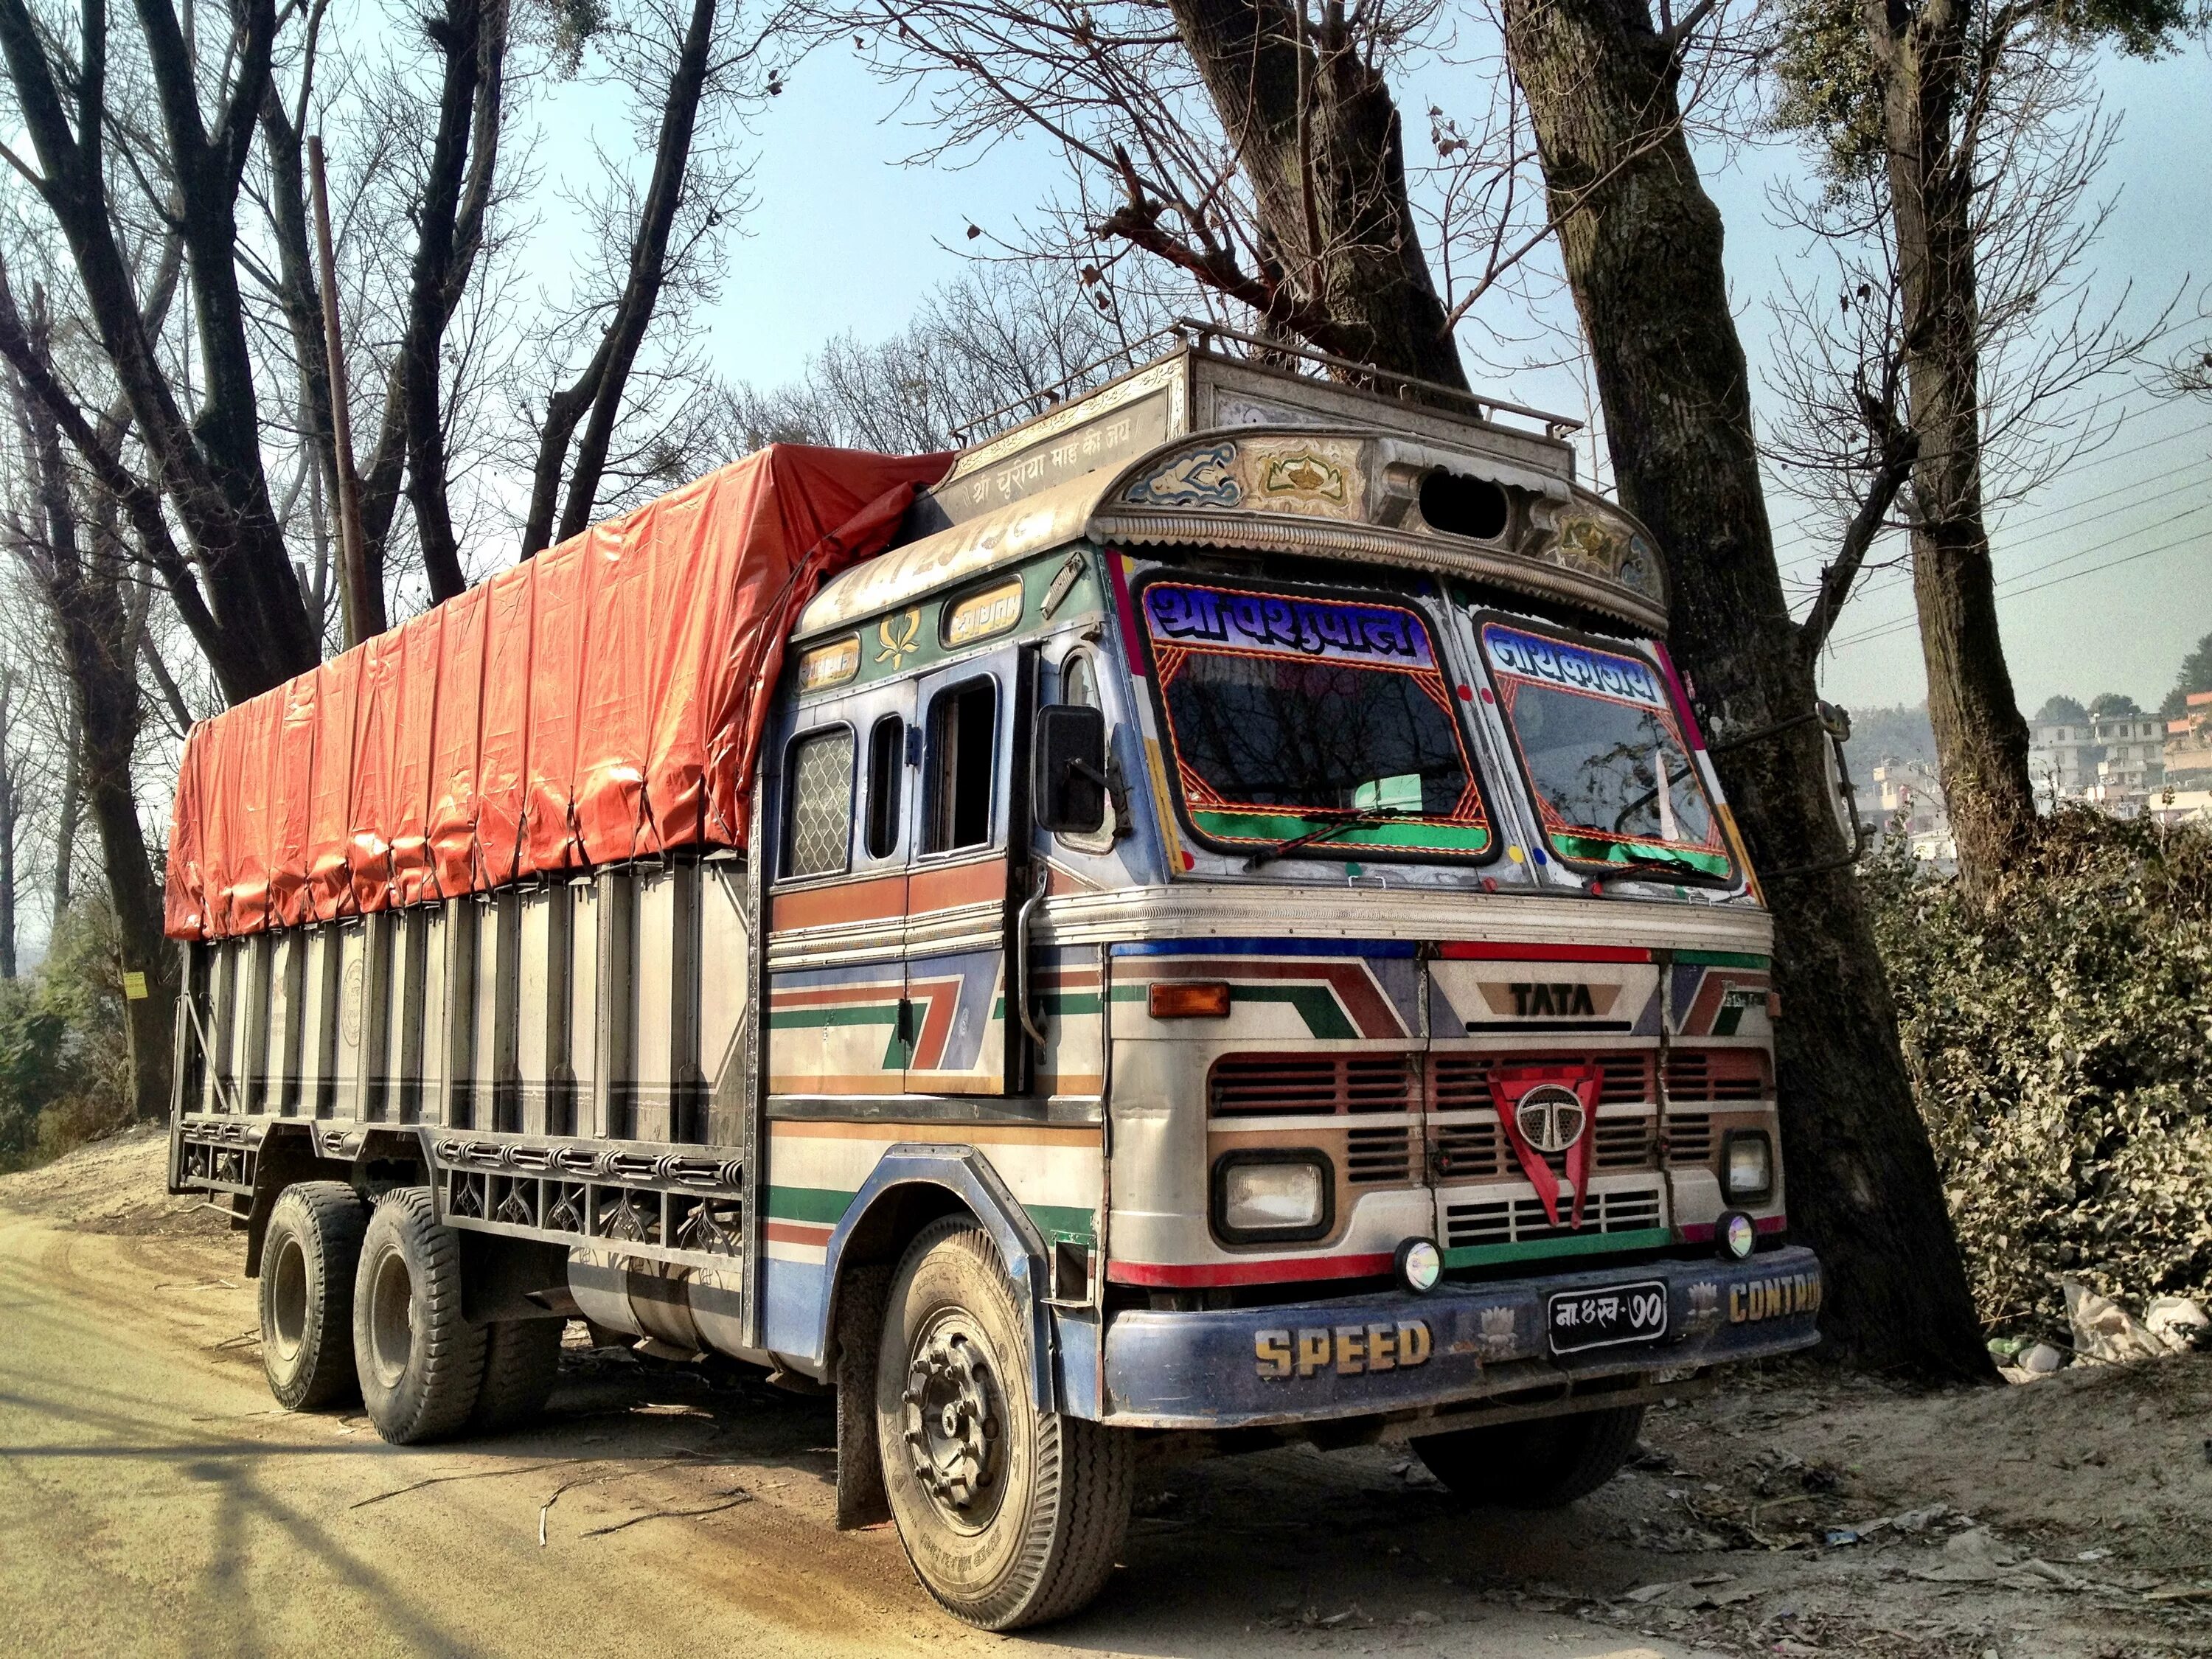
[168,445,951,938]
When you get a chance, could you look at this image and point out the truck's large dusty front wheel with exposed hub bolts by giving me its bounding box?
[876,1217,1133,1630]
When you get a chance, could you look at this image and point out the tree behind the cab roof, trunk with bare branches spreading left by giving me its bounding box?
[814,0,1473,387]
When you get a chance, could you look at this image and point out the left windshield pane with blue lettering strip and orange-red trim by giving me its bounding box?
[1141,582,1491,858]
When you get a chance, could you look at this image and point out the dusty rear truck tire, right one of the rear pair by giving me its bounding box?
[354,1186,484,1447]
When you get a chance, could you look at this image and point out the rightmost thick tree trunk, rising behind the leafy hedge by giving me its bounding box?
[1865,0,2035,891]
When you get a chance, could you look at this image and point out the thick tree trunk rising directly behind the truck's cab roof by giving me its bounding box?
[1168,0,1467,387]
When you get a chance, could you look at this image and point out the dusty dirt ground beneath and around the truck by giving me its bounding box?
[0,1137,2212,1659]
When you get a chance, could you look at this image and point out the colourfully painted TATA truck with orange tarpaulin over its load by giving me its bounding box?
[168,345,1823,1630]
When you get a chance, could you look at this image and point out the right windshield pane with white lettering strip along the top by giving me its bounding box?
[1482,622,1734,880]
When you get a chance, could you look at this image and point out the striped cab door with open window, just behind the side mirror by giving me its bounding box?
[900,648,1035,1095]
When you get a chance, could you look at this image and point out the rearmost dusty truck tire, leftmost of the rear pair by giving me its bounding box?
[259,1181,369,1411]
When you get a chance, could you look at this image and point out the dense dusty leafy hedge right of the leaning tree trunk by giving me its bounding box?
[1865,810,2212,1332]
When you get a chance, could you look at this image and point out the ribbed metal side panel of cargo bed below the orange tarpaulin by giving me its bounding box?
[170,854,757,1336]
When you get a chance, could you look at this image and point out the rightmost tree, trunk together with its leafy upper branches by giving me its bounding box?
[1776,0,2205,887]
